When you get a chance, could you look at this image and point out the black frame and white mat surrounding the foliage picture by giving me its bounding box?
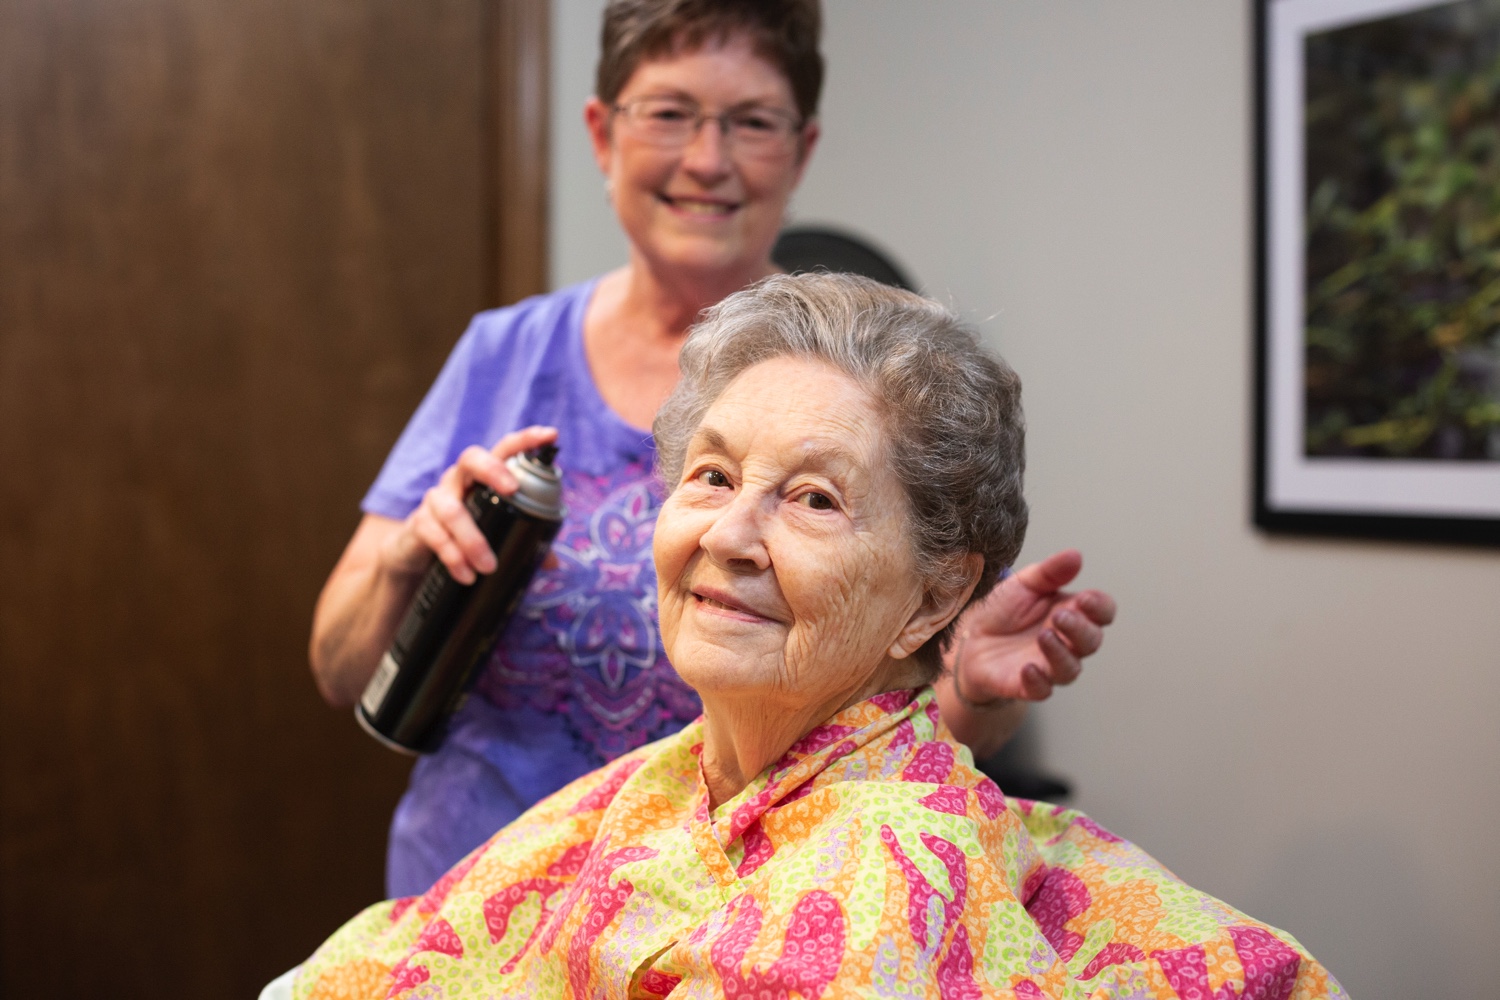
[1253,0,1500,546]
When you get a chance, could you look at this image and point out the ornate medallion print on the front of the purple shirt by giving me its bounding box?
[476,462,702,763]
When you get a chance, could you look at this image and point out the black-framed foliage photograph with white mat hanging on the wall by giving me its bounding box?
[1256,0,1500,544]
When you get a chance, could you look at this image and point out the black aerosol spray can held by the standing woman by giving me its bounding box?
[354,445,563,754]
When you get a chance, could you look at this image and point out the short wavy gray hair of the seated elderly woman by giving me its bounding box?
[653,273,1028,676]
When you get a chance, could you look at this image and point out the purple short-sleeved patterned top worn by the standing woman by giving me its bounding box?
[363,282,702,897]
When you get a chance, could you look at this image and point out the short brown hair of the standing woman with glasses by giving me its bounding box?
[594,0,824,121]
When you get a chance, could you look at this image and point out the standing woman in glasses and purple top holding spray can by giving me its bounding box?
[311,0,1115,897]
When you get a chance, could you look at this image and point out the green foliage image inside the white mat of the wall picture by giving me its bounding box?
[1305,0,1500,460]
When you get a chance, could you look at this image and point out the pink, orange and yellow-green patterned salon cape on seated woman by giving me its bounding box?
[294,688,1347,1000]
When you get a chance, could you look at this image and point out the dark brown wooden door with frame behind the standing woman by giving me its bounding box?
[0,0,546,997]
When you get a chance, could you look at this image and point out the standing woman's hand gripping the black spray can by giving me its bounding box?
[396,427,558,583]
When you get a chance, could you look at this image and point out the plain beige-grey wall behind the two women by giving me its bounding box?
[554,0,1500,1000]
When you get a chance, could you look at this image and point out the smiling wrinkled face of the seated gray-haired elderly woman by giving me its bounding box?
[656,357,947,721]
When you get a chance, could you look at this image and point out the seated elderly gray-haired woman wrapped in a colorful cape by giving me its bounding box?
[294,274,1344,1000]
